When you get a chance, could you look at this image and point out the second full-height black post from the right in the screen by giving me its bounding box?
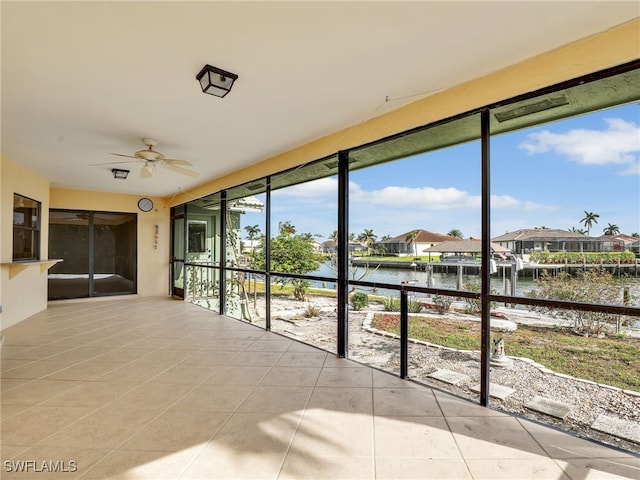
[336,151,349,358]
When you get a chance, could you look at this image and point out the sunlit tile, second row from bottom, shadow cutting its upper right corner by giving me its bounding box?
[374,416,462,458]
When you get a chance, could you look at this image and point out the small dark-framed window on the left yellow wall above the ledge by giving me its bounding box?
[13,193,40,260]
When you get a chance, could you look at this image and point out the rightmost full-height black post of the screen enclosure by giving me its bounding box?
[480,108,491,407]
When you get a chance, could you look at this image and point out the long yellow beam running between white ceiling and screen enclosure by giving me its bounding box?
[170,19,640,205]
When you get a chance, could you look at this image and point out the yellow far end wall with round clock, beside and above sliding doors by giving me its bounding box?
[50,188,170,295]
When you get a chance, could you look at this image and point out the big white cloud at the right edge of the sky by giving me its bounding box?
[519,118,640,170]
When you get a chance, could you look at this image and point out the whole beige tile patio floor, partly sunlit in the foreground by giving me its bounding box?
[0,296,640,480]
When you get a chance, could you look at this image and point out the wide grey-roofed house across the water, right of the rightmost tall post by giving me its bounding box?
[491,228,604,254]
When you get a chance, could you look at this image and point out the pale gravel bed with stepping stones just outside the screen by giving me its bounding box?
[262,298,640,453]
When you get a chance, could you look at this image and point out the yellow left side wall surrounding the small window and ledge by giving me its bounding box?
[0,159,49,329]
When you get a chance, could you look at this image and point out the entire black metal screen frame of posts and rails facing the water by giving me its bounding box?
[175,60,640,412]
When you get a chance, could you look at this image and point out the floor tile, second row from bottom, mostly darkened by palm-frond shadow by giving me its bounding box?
[209,412,301,455]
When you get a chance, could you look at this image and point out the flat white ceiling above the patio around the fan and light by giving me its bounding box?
[1,1,640,196]
